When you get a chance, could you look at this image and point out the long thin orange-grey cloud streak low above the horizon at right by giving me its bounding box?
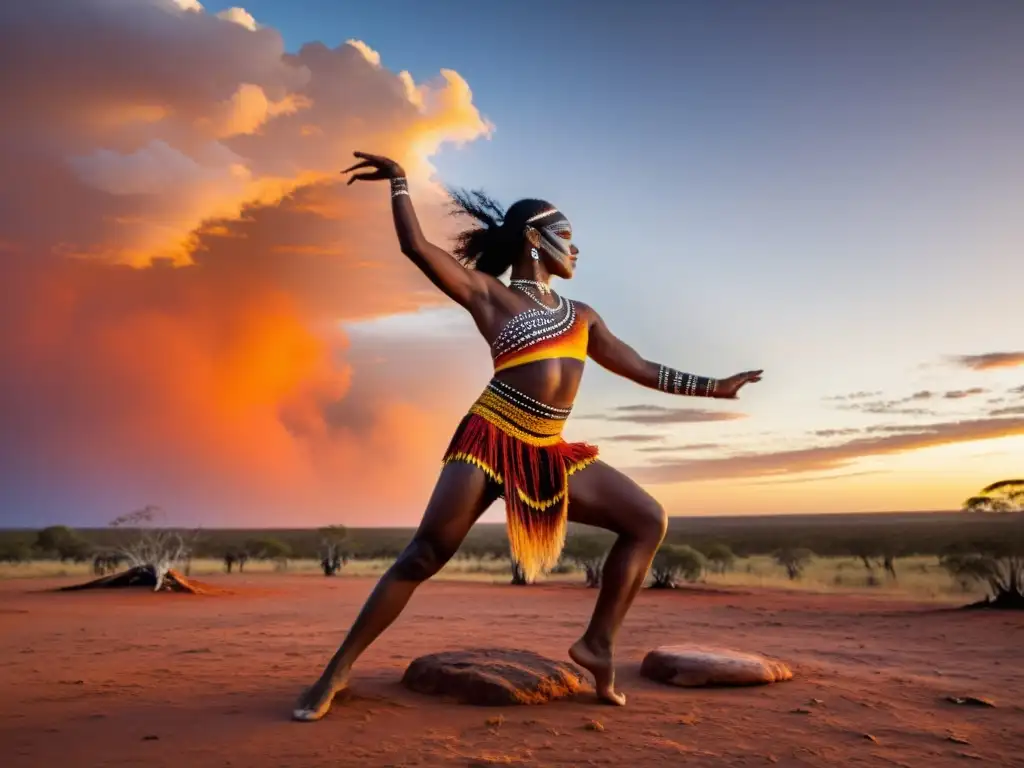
[629,418,1024,483]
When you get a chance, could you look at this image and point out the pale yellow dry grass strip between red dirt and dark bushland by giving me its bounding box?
[0,557,984,601]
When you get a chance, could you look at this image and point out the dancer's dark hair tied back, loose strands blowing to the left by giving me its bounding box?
[449,189,554,278]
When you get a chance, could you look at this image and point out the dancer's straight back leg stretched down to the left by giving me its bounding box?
[293,462,498,720]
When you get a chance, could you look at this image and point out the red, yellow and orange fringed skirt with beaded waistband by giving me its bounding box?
[443,379,597,581]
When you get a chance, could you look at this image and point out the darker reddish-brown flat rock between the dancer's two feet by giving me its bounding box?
[401,648,584,707]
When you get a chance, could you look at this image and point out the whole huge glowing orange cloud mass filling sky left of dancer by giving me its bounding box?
[0,0,489,525]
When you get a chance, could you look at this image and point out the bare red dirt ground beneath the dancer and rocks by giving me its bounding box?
[0,575,1024,768]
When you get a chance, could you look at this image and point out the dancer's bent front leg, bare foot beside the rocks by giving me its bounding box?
[569,462,668,706]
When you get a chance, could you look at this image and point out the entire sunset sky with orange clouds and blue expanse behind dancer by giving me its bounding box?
[0,0,1024,526]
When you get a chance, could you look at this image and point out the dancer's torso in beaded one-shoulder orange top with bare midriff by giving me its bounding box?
[490,297,590,409]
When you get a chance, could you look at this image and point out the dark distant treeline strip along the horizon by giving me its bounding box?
[6,512,1024,561]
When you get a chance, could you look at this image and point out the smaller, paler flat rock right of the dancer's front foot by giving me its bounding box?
[640,645,793,688]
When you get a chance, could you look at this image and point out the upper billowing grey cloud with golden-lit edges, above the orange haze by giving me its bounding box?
[0,0,490,263]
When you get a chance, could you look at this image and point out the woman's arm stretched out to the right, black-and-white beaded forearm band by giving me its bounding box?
[587,309,764,398]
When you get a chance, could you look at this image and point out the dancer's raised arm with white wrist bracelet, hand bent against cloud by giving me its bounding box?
[342,152,489,309]
